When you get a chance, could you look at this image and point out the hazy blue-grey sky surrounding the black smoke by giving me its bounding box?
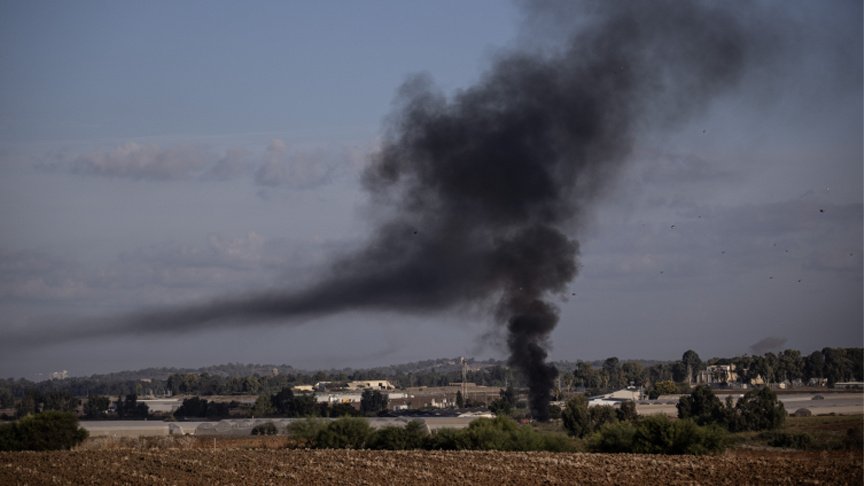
[0,0,864,378]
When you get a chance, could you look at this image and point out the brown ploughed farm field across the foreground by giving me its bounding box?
[0,448,864,485]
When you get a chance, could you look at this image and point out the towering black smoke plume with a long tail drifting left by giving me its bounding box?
[5,1,776,420]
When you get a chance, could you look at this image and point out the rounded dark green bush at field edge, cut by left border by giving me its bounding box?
[0,412,88,451]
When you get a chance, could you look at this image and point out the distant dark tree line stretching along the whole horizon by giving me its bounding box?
[0,348,864,418]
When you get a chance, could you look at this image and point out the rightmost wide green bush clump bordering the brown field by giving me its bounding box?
[589,415,726,454]
